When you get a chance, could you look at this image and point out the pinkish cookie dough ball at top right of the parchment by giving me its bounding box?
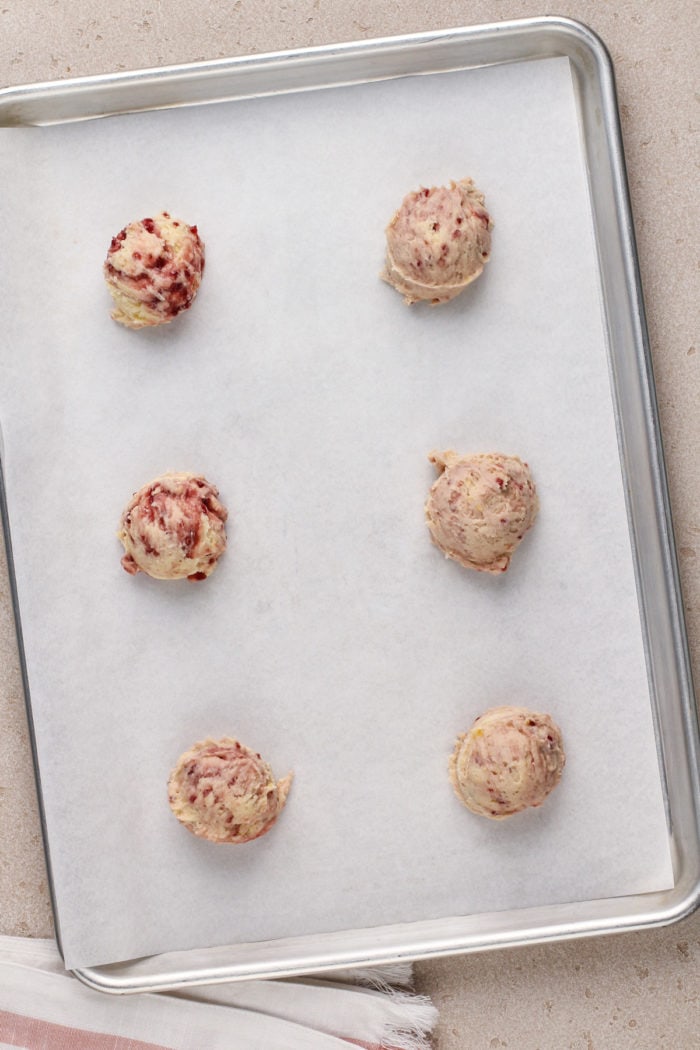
[381,179,493,306]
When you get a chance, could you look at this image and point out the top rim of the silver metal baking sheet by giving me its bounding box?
[0,16,604,127]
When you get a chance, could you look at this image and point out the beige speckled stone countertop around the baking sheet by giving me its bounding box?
[0,0,700,1050]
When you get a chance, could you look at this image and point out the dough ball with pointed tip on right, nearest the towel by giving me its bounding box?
[168,736,293,842]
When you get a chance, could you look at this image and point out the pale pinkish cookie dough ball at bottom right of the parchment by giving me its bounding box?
[449,707,566,820]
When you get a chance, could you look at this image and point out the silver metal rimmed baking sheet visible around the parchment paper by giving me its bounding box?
[0,19,697,991]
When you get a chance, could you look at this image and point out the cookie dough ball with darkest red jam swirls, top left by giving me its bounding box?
[104,211,205,329]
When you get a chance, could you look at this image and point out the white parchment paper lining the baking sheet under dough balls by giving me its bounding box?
[0,59,673,967]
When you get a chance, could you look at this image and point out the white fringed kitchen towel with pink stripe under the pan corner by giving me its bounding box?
[0,937,438,1050]
